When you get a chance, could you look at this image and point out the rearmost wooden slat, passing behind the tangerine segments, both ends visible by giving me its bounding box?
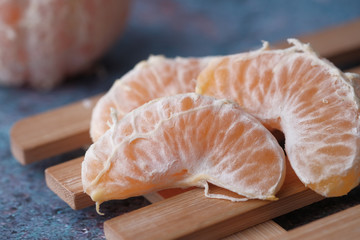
[10,19,360,164]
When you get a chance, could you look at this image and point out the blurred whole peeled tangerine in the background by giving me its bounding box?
[0,0,129,89]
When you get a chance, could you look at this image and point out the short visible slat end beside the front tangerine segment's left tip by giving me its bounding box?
[45,157,94,210]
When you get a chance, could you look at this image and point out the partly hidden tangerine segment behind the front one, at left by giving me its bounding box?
[90,56,213,142]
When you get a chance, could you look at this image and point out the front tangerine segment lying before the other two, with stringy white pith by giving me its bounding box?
[82,93,285,206]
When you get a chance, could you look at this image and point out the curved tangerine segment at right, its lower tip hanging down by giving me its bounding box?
[196,39,360,196]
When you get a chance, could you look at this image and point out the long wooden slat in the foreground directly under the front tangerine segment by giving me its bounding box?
[104,163,323,240]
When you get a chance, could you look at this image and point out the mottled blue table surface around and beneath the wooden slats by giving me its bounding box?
[0,0,360,239]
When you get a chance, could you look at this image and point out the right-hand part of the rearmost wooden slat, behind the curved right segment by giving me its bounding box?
[276,19,360,68]
